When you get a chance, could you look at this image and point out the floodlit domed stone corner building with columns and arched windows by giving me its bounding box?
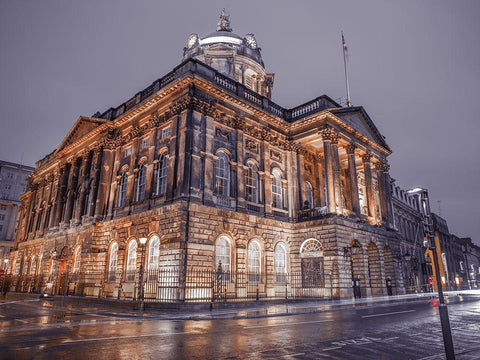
[10,13,405,301]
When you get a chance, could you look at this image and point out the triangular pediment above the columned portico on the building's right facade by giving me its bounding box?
[331,106,391,151]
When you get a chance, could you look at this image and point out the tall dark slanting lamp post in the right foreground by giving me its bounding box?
[408,188,455,360]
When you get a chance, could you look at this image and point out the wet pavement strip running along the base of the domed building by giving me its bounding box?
[0,289,480,320]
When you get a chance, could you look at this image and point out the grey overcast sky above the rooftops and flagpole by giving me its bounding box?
[0,0,480,242]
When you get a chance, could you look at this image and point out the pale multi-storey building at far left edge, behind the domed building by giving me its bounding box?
[0,160,35,271]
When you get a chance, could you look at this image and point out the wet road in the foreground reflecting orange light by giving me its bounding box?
[0,300,480,360]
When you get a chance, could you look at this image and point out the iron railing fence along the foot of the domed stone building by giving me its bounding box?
[4,267,332,302]
